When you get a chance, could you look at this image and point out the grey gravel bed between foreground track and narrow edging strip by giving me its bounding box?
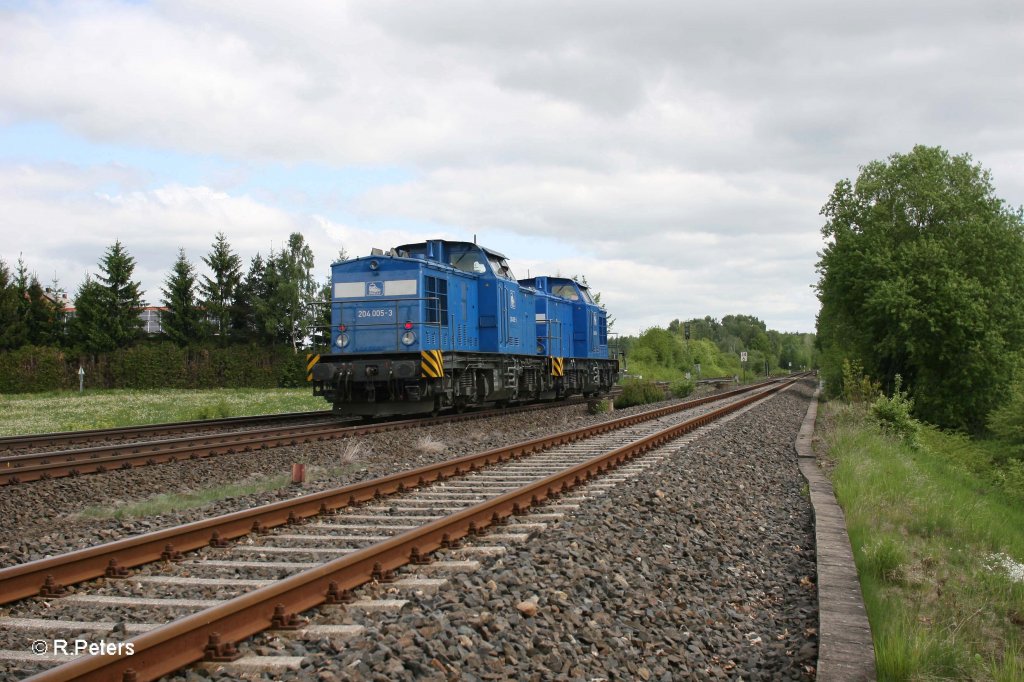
[211,383,817,682]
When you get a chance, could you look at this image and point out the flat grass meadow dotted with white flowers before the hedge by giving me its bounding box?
[0,387,329,435]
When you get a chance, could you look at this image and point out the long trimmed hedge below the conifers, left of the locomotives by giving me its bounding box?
[0,342,305,393]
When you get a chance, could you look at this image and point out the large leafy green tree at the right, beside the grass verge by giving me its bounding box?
[816,145,1024,430]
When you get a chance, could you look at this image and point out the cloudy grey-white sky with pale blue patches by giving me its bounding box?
[0,0,1024,334]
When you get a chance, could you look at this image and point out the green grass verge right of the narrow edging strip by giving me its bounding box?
[819,403,1024,681]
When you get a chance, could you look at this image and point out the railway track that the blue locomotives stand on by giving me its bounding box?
[0,398,618,485]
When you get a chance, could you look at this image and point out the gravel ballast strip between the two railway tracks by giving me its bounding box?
[0,385,724,567]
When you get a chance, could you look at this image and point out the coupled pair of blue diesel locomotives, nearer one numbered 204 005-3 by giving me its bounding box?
[312,240,618,417]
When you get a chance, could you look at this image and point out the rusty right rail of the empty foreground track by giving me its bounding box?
[24,379,797,682]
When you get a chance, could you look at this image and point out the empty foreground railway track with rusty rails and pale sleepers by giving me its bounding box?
[0,374,792,680]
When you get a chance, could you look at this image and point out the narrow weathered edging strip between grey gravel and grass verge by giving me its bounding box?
[796,389,877,682]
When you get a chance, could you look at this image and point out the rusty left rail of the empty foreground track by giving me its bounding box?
[0,382,773,604]
